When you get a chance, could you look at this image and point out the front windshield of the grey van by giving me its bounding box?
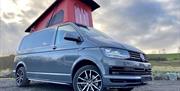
[79,27,110,39]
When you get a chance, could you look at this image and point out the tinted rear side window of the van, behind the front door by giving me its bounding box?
[20,29,54,50]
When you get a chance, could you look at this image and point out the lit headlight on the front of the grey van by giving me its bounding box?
[101,48,130,59]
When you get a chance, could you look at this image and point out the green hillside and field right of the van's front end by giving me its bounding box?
[148,53,180,72]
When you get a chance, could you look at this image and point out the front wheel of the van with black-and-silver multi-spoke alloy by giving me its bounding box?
[73,65,104,91]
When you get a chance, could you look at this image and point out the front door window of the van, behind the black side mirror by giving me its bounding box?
[56,25,79,46]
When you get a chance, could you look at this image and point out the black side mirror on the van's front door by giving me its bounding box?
[64,32,81,42]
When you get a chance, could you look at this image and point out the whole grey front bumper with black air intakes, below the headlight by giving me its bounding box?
[103,58,152,88]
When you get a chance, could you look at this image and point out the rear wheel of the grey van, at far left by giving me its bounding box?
[15,67,30,87]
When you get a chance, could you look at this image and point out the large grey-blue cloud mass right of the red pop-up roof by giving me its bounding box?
[94,0,180,52]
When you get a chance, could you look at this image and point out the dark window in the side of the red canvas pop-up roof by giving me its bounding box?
[48,10,64,26]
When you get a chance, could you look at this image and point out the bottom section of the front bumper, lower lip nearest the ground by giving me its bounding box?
[103,75,152,88]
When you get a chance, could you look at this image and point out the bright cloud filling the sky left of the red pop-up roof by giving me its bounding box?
[0,0,53,55]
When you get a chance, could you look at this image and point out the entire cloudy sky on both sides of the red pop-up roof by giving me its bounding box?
[0,0,180,55]
